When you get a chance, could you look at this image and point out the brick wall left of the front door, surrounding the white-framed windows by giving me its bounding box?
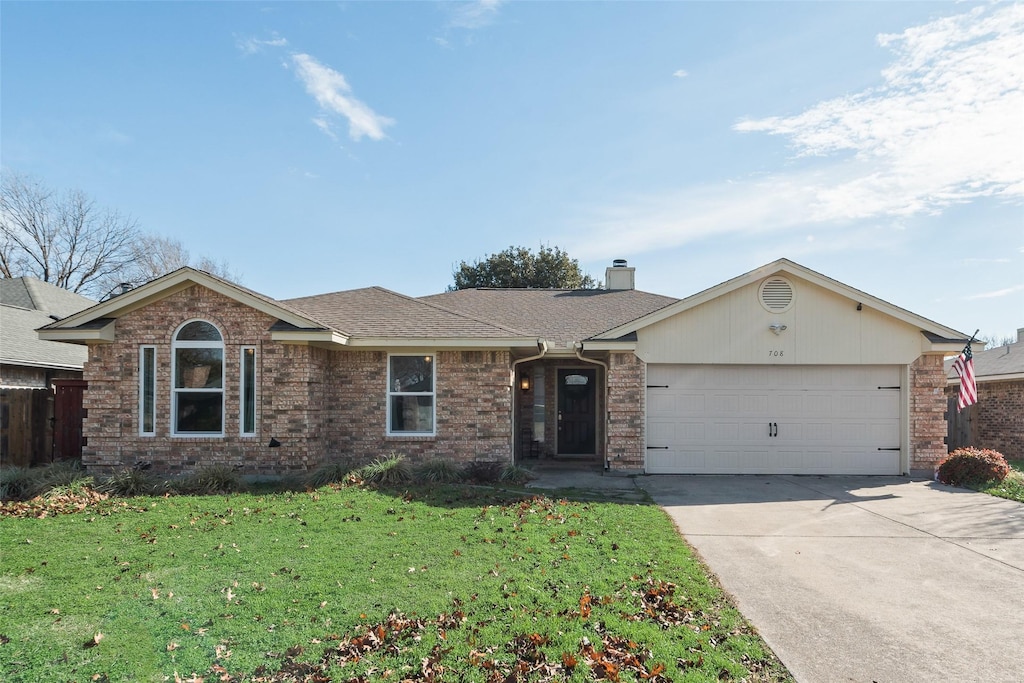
[82,286,512,475]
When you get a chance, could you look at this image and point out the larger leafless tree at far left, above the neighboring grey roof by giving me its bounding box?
[0,170,139,297]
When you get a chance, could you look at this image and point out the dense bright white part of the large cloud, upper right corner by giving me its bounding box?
[735,4,1024,217]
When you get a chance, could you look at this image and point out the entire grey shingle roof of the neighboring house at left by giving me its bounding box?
[0,278,95,370]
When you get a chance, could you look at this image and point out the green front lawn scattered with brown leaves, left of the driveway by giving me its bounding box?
[0,485,790,682]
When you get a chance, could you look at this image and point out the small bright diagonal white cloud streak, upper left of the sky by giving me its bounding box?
[292,54,394,141]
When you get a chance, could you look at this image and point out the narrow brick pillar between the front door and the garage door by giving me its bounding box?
[607,353,646,472]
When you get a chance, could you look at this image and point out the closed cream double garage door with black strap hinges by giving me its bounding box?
[647,365,900,474]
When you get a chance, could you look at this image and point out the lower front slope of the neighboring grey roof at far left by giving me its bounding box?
[0,304,89,370]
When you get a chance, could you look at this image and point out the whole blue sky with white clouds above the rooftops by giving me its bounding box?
[0,0,1024,338]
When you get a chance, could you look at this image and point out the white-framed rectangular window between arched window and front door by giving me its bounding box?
[387,354,434,435]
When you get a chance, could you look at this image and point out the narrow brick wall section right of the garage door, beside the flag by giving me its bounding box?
[909,355,946,470]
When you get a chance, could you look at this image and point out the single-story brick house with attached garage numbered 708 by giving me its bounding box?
[40,259,966,474]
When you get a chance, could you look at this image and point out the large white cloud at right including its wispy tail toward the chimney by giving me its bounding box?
[573,4,1024,258]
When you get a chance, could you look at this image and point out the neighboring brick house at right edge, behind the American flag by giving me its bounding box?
[946,328,1024,460]
